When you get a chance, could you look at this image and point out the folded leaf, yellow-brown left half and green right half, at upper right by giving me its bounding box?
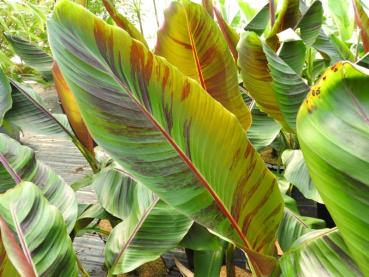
[238,32,309,132]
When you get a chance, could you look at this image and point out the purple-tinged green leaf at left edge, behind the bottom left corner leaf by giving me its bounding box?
[0,134,77,232]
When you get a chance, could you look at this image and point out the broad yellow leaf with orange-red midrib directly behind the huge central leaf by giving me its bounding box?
[155,2,251,130]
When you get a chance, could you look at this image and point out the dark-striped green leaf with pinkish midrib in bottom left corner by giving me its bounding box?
[0,182,78,276]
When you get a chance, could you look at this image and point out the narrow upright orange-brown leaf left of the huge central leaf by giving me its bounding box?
[51,62,94,155]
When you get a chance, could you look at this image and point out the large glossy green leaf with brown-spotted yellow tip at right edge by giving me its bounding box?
[297,62,369,275]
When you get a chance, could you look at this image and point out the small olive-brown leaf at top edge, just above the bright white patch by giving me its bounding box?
[266,0,300,51]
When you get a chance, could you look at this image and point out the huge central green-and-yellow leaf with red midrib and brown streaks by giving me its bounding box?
[48,1,283,274]
